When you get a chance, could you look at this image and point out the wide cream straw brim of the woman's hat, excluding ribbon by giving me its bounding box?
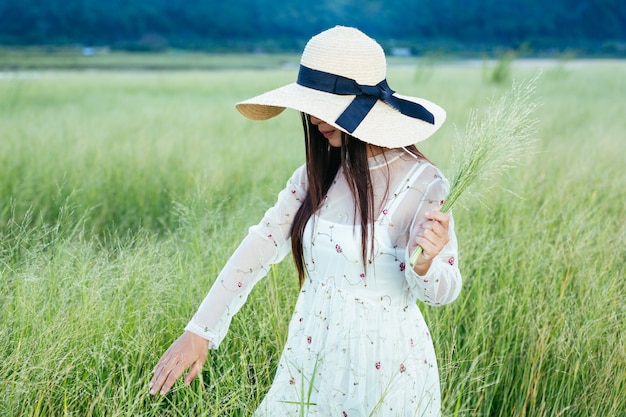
[235,83,446,148]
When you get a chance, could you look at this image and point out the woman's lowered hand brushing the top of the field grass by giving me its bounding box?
[149,331,209,395]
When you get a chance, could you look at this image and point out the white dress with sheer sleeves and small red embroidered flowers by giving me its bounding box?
[186,149,461,417]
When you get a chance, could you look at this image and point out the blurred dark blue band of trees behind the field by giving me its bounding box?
[0,0,626,55]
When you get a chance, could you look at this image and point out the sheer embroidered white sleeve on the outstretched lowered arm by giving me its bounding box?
[185,166,307,349]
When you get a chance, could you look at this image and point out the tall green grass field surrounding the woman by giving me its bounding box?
[0,61,626,417]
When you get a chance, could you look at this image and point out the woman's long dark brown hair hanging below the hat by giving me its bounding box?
[291,113,426,286]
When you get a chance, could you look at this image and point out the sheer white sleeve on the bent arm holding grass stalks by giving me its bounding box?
[405,168,462,306]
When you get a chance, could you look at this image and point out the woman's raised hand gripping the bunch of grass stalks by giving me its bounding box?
[411,210,450,275]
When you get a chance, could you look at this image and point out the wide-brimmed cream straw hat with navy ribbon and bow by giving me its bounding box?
[236,26,446,148]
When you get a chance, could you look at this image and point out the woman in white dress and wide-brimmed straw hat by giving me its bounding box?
[150,27,461,416]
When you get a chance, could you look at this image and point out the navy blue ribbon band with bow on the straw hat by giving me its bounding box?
[296,65,435,133]
